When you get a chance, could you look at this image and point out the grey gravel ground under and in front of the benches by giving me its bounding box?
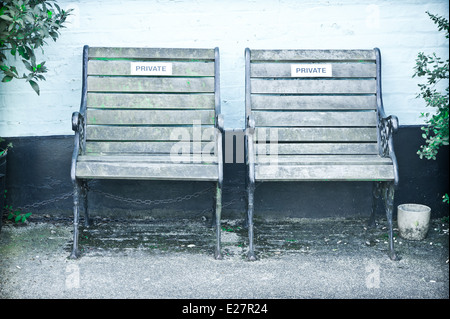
[0,216,449,300]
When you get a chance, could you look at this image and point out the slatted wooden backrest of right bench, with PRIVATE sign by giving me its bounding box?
[246,49,379,155]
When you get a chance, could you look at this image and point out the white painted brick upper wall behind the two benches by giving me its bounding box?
[0,0,449,137]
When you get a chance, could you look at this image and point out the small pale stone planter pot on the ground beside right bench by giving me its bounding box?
[397,204,431,240]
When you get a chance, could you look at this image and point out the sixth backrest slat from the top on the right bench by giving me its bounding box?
[254,127,377,142]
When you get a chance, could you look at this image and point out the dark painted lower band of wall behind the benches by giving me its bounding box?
[1,126,449,218]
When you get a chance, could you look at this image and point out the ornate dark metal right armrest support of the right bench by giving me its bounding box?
[380,115,399,187]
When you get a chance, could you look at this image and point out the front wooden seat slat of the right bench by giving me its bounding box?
[255,165,394,181]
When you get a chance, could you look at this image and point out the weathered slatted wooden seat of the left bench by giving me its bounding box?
[76,155,219,181]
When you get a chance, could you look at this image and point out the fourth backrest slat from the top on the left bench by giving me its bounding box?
[87,93,214,109]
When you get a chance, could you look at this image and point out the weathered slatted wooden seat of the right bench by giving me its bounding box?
[255,155,394,181]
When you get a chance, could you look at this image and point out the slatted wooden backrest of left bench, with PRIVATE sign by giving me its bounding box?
[81,46,220,159]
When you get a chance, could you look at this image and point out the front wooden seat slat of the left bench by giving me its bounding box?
[76,162,218,181]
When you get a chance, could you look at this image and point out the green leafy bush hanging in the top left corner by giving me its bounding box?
[0,0,71,95]
